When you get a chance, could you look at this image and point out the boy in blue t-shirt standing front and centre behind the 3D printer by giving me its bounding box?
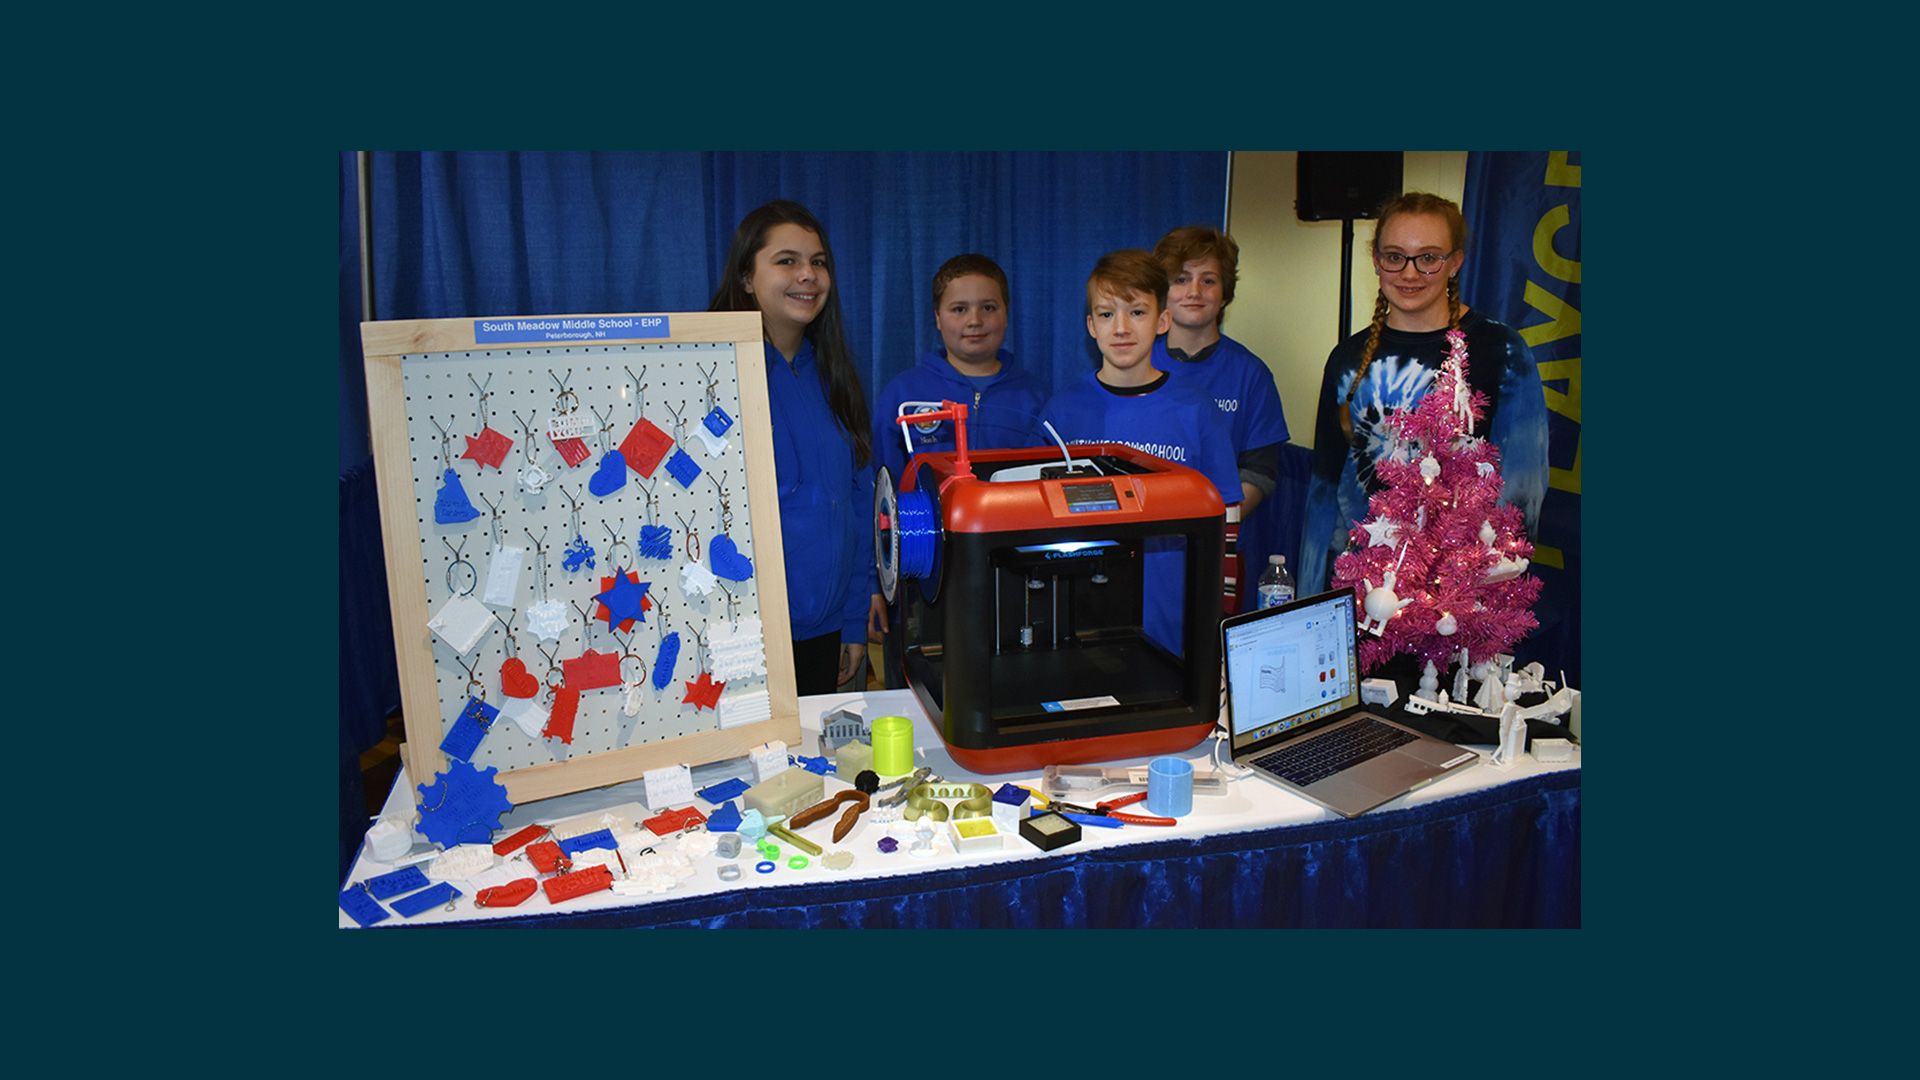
[1041,250,1240,655]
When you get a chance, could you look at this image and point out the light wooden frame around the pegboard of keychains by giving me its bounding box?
[361,311,801,809]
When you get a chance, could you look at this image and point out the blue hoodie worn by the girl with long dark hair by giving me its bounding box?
[766,340,874,646]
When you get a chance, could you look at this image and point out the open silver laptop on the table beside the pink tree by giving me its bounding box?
[1219,588,1480,817]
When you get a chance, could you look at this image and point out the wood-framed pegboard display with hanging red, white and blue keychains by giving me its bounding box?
[363,313,799,803]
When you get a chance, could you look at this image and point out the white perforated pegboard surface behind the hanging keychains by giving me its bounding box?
[401,344,778,773]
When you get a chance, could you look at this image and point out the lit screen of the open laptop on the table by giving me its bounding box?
[1223,588,1359,753]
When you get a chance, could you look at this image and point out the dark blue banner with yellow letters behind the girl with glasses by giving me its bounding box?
[1461,150,1580,686]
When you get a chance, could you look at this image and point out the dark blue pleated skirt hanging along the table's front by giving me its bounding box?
[416,769,1580,930]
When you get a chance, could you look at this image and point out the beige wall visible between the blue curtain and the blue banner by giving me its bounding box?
[1223,150,1467,446]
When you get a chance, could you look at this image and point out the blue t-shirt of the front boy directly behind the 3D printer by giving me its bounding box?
[1041,375,1240,655]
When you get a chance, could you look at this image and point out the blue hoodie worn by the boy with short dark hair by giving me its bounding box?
[874,348,1052,480]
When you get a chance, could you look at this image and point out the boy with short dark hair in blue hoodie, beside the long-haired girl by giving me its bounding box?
[868,254,1048,688]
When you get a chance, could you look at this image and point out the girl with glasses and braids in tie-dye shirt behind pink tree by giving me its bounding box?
[1298,192,1548,596]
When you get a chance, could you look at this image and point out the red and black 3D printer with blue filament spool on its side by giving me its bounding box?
[874,402,1225,773]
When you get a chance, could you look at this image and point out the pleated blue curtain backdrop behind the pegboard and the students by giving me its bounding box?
[360,152,1227,394]
